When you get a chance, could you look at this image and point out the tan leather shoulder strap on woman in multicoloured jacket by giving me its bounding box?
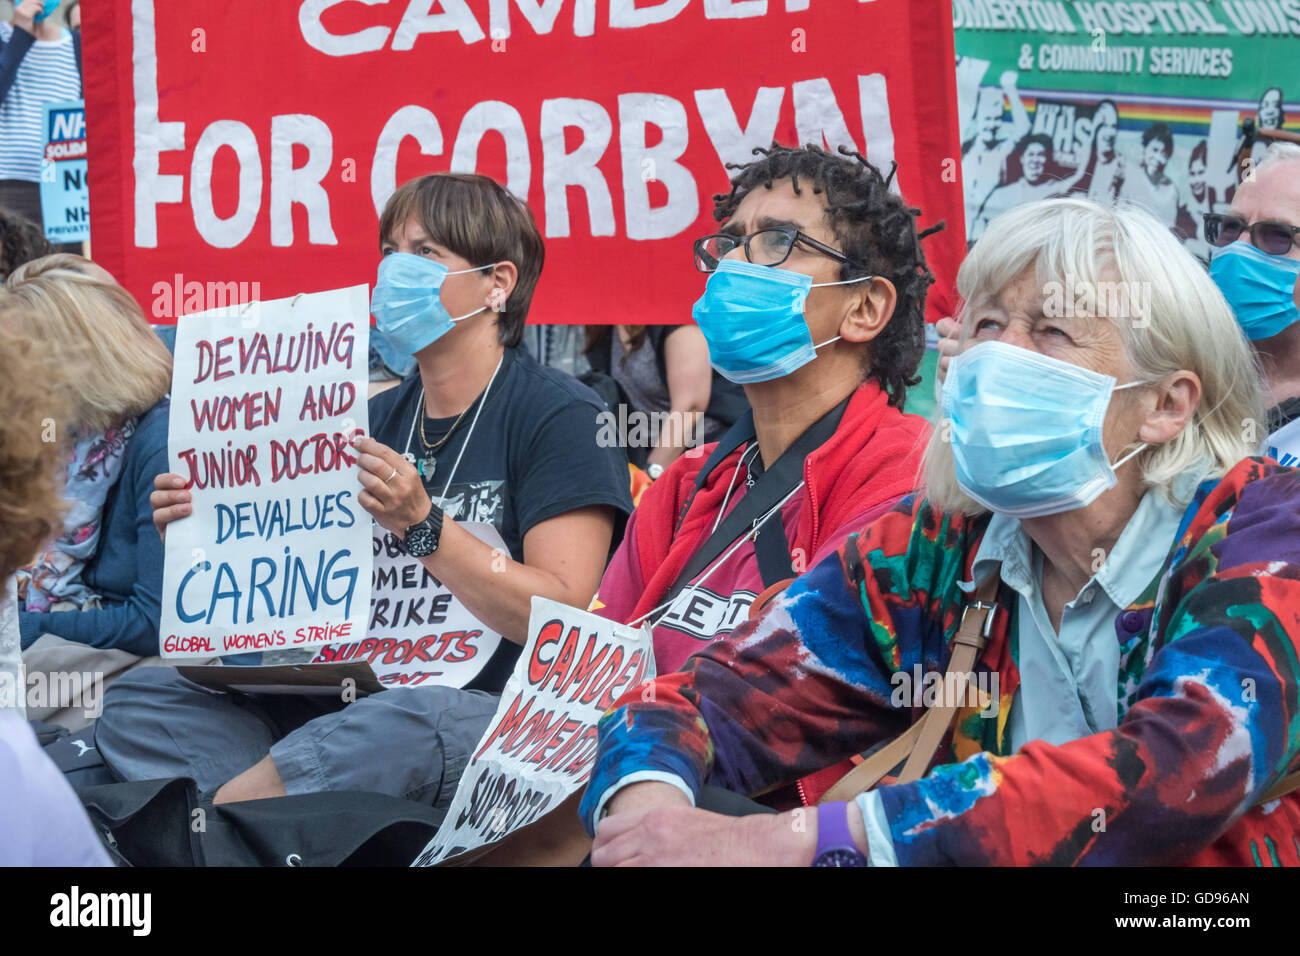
[820,571,1000,804]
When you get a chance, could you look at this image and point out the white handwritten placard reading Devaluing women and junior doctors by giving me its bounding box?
[160,285,371,657]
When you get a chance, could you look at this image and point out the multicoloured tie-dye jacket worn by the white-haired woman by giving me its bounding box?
[581,459,1300,865]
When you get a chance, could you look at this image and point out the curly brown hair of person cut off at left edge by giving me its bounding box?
[0,317,75,580]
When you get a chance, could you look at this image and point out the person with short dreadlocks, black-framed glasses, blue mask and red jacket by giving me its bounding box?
[594,144,933,804]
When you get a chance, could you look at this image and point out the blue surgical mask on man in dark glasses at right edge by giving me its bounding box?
[1210,242,1300,341]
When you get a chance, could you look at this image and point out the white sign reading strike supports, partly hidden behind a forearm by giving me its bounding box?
[312,522,506,687]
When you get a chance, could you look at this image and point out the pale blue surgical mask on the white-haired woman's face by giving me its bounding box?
[943,342,1147,518]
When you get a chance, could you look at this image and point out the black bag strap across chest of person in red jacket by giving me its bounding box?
[658,395,852,613]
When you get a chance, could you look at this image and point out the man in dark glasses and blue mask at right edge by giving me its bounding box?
[1204,143,1300,466]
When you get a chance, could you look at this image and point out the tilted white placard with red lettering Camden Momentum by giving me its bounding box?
[413,597,654,866]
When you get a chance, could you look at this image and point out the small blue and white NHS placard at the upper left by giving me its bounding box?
[40,100,90,243]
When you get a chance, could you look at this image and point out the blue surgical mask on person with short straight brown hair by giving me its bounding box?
[371,252,493,356]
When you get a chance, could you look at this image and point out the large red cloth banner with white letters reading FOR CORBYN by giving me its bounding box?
[85,0,965,324]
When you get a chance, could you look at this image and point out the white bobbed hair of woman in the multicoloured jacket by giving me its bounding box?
[923,199,1265,514]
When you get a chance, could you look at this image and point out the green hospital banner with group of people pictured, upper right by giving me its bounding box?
[953,0,1300,261]
